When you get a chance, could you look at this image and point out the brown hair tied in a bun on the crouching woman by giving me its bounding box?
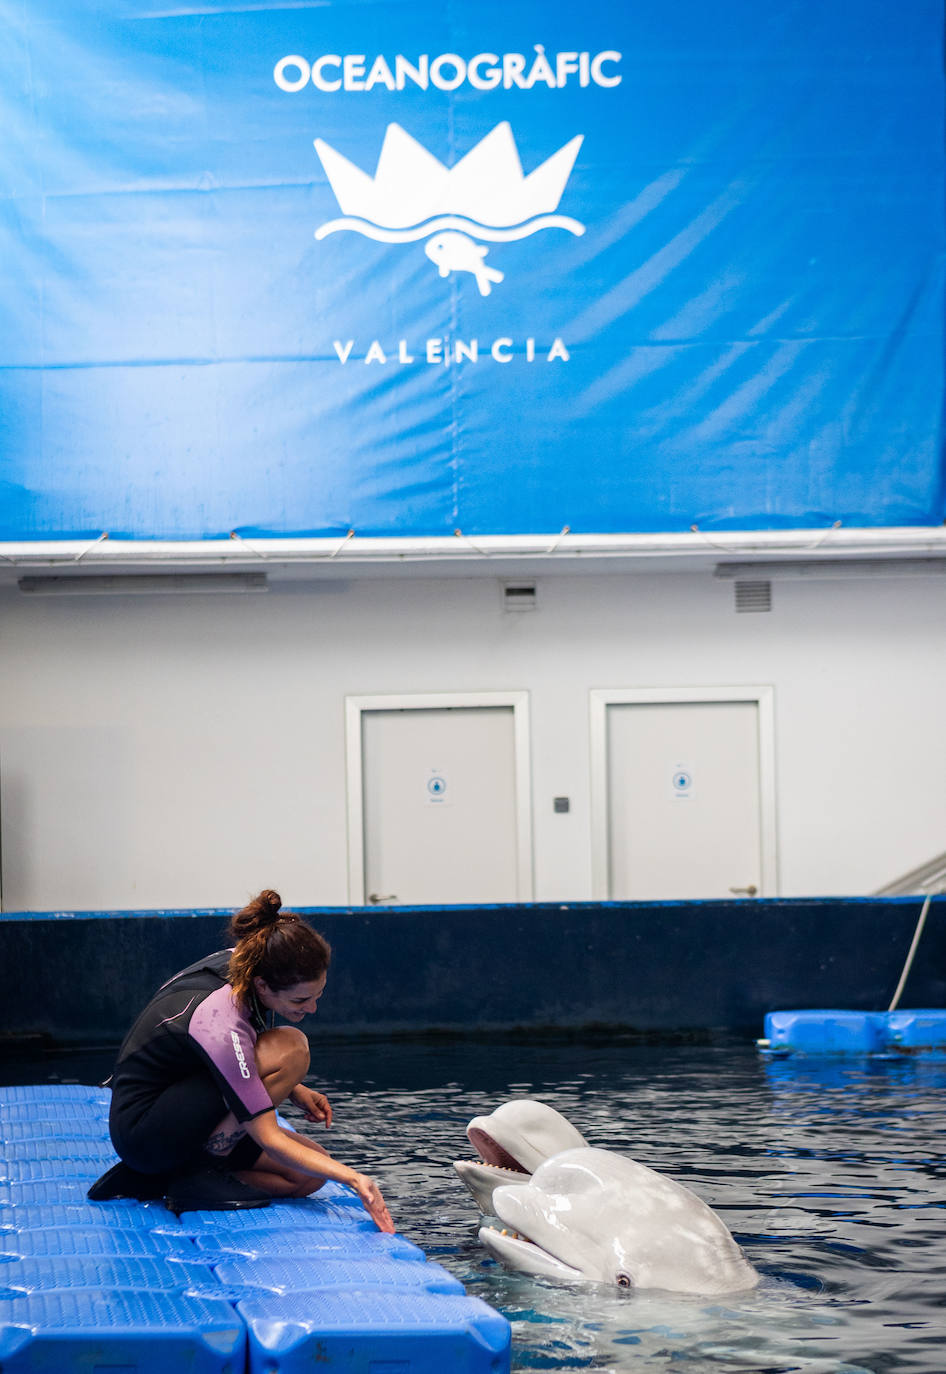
[228,888,332,1004]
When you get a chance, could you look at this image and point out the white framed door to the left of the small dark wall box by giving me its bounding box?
[351,703,531,905]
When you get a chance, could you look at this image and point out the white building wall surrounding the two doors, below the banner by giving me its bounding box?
[0,573,946,911]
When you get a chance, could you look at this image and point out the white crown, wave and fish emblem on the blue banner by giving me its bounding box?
[314,121,585,295]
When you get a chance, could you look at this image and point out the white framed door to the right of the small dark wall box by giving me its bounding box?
[604,699,772,900]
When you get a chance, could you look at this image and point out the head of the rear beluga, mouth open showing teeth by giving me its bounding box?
[453,1098,586,1216]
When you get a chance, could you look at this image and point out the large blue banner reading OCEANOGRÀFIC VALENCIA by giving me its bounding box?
[0,0,946,540]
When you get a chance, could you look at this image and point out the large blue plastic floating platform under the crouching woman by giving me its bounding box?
[0,1084,509,1374]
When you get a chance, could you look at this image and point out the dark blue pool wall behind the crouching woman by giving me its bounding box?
[0,897,946,1044]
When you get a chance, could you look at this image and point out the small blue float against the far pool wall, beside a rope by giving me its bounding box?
[759,1009,946,1057]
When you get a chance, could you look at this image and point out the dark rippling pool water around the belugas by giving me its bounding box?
[7,1031,946,1374]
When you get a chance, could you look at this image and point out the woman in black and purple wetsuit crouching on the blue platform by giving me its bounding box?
[88,890,394,1231]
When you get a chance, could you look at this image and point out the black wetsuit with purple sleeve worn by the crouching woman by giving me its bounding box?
[108,949,273,1173]
